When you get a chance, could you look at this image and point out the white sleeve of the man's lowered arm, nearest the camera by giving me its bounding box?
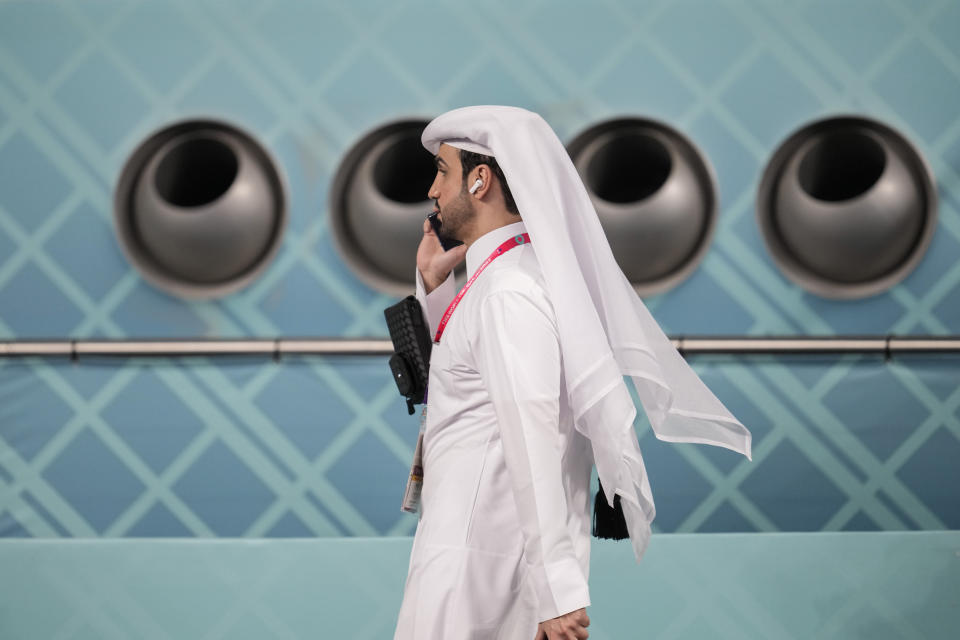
[473,291,590,621]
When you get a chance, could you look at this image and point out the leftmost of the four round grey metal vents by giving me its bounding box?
[114,120,287,299]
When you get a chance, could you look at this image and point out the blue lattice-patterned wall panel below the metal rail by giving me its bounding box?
[0,358,960,537]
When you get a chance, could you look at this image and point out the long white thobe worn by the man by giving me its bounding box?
[394,222,593,640]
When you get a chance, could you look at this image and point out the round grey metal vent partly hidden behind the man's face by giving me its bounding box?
[330,120,436,296]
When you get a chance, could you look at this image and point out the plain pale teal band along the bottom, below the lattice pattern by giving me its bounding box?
[0,532,960,640]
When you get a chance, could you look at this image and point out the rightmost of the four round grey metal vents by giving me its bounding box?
[757,117,937,298]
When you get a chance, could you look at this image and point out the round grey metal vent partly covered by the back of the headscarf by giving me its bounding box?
[567,118,717,295]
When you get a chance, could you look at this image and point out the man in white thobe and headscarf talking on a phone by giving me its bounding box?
[395,107,750,640]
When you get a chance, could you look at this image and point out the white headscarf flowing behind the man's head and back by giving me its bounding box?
[422,106,751,560]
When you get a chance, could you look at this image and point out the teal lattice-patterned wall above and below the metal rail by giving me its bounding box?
[0,0,960,537]
